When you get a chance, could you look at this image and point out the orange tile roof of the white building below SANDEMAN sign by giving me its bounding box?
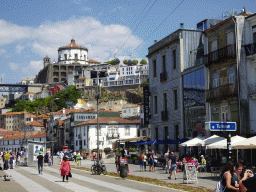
[75,117,140,127]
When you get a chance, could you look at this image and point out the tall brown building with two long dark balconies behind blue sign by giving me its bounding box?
[204,12,255,136]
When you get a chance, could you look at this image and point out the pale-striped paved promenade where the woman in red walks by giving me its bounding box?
[0,160,188,192]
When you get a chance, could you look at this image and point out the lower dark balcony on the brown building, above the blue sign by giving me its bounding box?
[206,83,237,101]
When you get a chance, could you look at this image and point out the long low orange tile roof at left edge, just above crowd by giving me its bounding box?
[1,131,46,140]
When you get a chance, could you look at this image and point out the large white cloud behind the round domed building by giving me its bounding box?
[32,17,142,61]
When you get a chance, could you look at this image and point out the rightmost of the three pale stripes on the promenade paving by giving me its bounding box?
[47,167,142,192]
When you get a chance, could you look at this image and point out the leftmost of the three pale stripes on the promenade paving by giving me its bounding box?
[8,169,51,192]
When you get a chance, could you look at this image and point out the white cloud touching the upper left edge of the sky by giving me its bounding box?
[0,19,32,45]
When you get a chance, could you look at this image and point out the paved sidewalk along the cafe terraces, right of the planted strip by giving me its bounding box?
[76,160,220,190]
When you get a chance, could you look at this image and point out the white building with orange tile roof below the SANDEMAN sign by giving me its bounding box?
[74,117,139,150]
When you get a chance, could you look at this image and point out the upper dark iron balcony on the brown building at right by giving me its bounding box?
[204,45,236,67]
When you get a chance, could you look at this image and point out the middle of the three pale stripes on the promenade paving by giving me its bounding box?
[21,167,96,192]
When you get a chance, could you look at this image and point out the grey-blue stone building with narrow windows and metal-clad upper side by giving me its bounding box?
[147,24,207,152]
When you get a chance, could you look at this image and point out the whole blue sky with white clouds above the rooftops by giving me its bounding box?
[0,0,256,83]
